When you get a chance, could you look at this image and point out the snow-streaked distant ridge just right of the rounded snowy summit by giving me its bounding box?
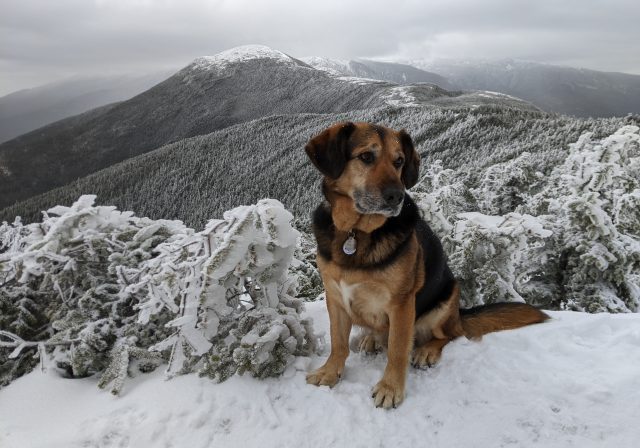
[301,56,453,89]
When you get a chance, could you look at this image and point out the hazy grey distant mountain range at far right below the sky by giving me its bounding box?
[409,59,640,117]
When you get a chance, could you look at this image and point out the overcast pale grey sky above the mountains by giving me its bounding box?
[0,0,640,95]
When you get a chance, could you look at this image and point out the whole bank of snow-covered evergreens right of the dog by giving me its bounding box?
[414,125,640,312]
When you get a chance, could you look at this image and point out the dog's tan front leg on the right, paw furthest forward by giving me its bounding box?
[373,297,415,409]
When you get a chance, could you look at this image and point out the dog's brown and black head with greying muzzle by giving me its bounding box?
[305,122,420,217]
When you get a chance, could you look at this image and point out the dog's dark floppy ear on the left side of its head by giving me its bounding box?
[304,122,356,179]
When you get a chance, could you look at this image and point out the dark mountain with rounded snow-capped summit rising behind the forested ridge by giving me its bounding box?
[0,46,535,207]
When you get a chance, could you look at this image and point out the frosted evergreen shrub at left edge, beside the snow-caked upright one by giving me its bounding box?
[0,196,176,384]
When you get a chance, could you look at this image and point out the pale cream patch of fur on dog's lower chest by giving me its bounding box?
[329,278,391,330]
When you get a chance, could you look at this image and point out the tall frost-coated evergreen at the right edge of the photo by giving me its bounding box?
[529,126,640,312]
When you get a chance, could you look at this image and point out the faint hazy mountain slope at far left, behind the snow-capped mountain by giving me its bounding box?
[0,70,173,143]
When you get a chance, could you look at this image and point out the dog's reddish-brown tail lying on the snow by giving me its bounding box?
[460,303,549,339]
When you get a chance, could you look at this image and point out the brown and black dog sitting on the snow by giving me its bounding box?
[305,123,548,408]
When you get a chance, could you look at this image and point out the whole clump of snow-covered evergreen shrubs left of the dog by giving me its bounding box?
[0,196,316,393]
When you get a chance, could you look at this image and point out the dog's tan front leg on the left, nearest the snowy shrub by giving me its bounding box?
[307,291,351,387]
